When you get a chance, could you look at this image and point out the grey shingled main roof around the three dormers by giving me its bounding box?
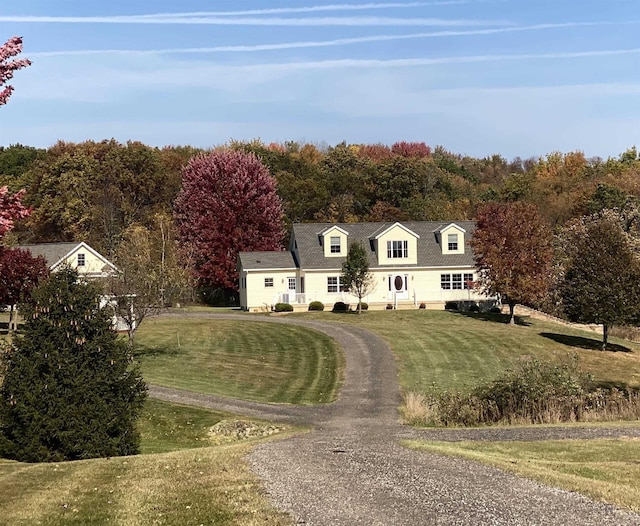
[292,221,475,270]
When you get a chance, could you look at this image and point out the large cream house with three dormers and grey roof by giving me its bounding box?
[238,221,489,311]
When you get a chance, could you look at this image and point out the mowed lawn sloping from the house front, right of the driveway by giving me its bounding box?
[300,310,640,392]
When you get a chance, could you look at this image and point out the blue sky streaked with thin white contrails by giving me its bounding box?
[0,0,640,159]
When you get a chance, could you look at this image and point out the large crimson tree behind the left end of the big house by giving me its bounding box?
[174,149,284,291]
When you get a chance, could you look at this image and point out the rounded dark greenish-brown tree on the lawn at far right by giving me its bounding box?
[559,212,640,350]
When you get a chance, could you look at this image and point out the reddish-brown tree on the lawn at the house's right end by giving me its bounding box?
[471,202,553,323]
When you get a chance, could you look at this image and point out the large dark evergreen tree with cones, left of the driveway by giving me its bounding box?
[0,269,146,462]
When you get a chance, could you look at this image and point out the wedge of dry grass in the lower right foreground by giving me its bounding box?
[408,438,640,511]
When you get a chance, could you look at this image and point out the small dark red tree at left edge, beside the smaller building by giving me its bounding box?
[0,247,49,331]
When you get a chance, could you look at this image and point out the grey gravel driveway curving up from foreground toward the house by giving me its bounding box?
[150,313,640,526]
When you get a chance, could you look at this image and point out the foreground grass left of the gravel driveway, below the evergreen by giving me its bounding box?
[0,400,291,526]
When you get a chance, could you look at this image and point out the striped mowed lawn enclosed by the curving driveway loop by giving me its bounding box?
[136,317,344,404]
